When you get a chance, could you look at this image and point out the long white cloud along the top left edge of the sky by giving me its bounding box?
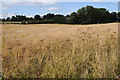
[0,0,56,10]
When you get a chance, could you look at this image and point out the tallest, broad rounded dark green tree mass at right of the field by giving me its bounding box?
[77,6,110,24]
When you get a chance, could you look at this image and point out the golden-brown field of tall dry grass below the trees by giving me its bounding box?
[0,23,120,78]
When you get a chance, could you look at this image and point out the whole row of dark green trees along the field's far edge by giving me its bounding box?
[2,6,120,24]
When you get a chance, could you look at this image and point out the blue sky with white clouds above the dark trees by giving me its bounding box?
[0,0,118,18]
